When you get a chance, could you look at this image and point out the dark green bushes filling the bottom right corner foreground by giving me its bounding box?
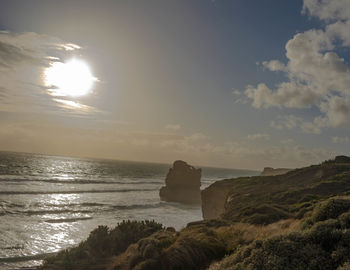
[212,197,350,270]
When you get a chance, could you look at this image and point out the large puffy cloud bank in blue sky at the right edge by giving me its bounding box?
[244,0,350,133]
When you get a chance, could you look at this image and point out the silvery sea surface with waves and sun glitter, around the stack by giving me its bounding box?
[0,152,257,269]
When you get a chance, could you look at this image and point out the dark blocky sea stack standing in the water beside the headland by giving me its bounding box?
[159,160,202,204]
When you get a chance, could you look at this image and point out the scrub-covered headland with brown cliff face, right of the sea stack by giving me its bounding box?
[202,157,350,224]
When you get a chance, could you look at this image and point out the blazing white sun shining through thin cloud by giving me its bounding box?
[44,59,96,97]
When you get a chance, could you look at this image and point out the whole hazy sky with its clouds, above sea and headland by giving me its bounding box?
[0,0,350,170]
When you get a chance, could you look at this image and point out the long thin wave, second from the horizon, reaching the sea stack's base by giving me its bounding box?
[0,188,159,195]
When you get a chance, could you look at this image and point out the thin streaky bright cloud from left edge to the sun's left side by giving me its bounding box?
[0,31,97,114]
